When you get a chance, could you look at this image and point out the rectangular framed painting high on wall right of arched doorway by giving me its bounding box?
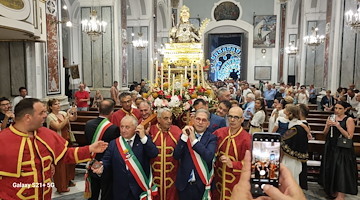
[254,15,276,48]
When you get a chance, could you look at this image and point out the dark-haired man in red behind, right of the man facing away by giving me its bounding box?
[111,92,141,127]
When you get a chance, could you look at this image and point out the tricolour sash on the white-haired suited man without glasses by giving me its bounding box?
[116,136,158,200]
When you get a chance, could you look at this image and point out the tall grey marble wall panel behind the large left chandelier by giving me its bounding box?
[80,6,114,88]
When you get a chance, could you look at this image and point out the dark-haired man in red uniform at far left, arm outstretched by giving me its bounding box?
[0,98,107,200]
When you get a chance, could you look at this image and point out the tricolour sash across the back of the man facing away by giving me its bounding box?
[84,118,113,199]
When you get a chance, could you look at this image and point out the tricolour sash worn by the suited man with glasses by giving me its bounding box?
[186,139,215,200]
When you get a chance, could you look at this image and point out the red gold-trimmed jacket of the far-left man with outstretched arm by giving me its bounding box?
[0,126,90,200]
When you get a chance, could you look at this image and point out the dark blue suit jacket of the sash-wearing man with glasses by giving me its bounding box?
[174,130,217,191]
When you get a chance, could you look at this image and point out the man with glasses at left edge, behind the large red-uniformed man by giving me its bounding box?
[0,97,14,130]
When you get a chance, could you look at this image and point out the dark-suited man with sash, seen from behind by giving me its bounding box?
[85,100,120,200]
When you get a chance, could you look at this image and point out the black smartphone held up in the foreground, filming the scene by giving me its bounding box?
[250,132,281,197]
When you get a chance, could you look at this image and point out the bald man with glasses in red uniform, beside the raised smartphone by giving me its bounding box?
[213,107,251,200]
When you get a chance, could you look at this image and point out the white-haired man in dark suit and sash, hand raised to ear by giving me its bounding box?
[94,115,158,200]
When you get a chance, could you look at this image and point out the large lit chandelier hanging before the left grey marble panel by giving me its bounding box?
[81,10,107,41]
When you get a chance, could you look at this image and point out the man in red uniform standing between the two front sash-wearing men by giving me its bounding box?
[150,108,182,200]
